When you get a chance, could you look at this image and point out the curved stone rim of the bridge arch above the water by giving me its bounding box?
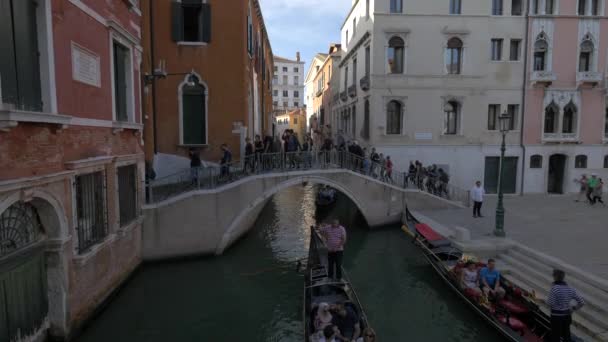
[215,175,369,255]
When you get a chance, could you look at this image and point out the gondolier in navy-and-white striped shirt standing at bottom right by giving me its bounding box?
[547,270,585,342]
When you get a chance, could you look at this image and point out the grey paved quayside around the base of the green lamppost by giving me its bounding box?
[421,195,608,279]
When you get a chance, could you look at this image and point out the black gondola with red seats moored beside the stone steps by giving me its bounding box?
[402,209,551,342]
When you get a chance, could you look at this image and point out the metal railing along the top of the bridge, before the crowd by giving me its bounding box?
[146,150,470,206]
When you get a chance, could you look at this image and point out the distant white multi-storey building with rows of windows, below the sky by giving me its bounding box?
[272,52,304,114]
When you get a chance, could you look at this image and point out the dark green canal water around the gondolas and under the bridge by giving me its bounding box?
[78,185,502,342]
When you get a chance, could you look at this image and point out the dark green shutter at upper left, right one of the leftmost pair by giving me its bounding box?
[11,0,42,111]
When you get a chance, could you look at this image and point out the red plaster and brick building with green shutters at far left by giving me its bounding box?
[0,0,144,341]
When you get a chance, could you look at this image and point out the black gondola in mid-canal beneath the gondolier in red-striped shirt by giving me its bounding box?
[302,227,369,342]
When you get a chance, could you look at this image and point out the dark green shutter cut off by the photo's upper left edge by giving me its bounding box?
[0,0,19,107]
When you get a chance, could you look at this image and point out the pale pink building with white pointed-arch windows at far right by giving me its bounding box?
[523,0,608,193]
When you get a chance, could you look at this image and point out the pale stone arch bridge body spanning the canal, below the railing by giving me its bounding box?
[143,168,460,260]
